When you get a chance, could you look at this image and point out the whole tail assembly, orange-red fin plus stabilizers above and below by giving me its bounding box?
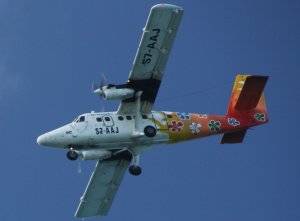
[221,74,268,144]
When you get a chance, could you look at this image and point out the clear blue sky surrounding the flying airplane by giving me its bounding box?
[0,0,300,221]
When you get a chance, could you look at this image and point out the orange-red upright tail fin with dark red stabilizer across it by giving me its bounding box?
[227,74,268,115]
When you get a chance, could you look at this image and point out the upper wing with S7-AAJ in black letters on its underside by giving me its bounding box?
[118,4,183,114]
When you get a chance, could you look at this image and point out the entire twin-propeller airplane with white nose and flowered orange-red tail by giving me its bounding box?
[37,4,269,218]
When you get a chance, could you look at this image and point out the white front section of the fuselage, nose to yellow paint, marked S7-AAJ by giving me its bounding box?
[38,111,169,153]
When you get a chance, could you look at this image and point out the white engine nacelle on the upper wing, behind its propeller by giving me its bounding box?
[102,87,134,100]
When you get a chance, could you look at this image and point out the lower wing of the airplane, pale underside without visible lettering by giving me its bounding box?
[75,152,131,218]
